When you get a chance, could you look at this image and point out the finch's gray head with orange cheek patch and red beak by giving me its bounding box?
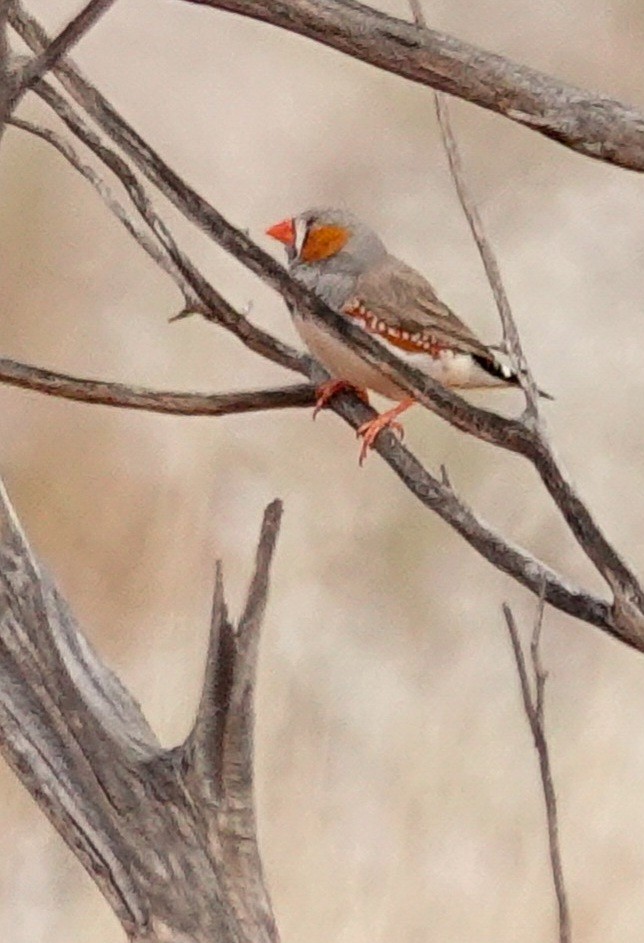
[266,207,387,276]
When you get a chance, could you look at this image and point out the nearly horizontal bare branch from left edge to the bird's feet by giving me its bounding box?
[0,358,315,416]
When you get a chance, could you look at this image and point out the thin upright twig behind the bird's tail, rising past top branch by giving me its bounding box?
[409,0,539,421]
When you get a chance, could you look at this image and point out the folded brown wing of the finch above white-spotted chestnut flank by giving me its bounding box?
[345,256,496,361]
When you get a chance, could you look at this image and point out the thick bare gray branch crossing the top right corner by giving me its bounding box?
[169,0,644,171]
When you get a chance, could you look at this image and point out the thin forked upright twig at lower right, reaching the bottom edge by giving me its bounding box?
[503,591,572,943]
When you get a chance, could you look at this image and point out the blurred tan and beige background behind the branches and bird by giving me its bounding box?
[0,0,644,943]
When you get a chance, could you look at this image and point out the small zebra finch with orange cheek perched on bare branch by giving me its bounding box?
[266,208,544,464]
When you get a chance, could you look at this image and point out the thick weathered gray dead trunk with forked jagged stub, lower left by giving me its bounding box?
[0,480,281,943]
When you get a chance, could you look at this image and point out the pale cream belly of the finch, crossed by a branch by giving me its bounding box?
[293,315,506,400]
